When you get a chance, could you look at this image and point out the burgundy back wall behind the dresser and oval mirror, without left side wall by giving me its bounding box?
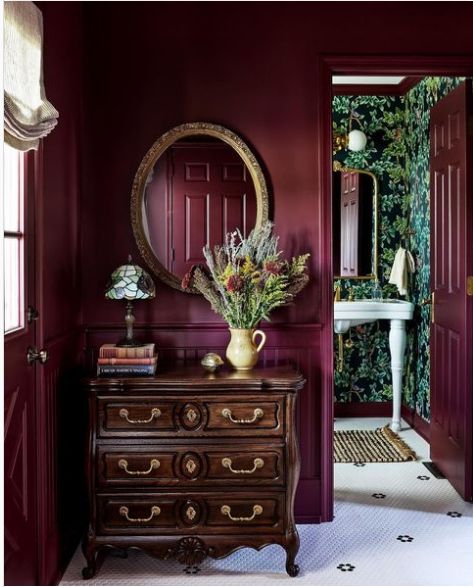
[82,2,472,521]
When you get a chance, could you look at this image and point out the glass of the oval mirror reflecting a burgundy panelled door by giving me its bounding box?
[145,136,256,276]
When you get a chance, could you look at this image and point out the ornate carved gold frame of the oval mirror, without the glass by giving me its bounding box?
[131,122,269,293]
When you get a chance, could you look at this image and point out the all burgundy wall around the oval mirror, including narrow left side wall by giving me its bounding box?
[25,2,472,584]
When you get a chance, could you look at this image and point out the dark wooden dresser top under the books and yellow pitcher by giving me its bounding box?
[85,364,305,391]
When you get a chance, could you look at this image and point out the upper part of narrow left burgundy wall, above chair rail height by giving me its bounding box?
[38,2,83,341]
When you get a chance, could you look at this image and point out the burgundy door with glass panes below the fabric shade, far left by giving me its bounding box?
[4,153,37,585]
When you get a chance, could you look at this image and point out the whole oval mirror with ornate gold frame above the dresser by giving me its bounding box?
[131,122,268,293]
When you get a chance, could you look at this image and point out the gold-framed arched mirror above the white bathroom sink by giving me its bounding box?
[332,161,378,279]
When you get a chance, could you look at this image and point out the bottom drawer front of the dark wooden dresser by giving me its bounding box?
[97,492,285,536]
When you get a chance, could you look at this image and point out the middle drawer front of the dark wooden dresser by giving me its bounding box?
[96,444,285,487]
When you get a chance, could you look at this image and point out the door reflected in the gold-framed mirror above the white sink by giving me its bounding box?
[340,171,360,277]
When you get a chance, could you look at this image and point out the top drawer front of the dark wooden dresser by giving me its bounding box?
[98,395,285,438]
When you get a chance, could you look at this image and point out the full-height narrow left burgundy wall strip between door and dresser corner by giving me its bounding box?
[36,2,85,585]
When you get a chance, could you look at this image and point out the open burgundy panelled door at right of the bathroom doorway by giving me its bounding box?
[430,82,473,500]
